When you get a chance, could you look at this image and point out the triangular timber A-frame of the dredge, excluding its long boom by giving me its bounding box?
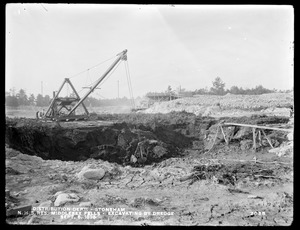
[45,78,89,121]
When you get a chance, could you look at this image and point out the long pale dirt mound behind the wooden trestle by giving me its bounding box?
[144,93,294,117]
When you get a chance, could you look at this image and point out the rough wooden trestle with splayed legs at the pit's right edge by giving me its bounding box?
[206,122,293,153]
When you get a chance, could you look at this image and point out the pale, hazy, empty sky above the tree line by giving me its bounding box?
[5,4,294,98]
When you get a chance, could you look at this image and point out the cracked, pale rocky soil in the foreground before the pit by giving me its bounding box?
[6,146,293,226]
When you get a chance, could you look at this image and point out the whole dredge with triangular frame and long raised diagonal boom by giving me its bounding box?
[37,50,127,121]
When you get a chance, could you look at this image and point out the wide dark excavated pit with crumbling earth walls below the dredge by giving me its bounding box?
[5,112,289,166]
